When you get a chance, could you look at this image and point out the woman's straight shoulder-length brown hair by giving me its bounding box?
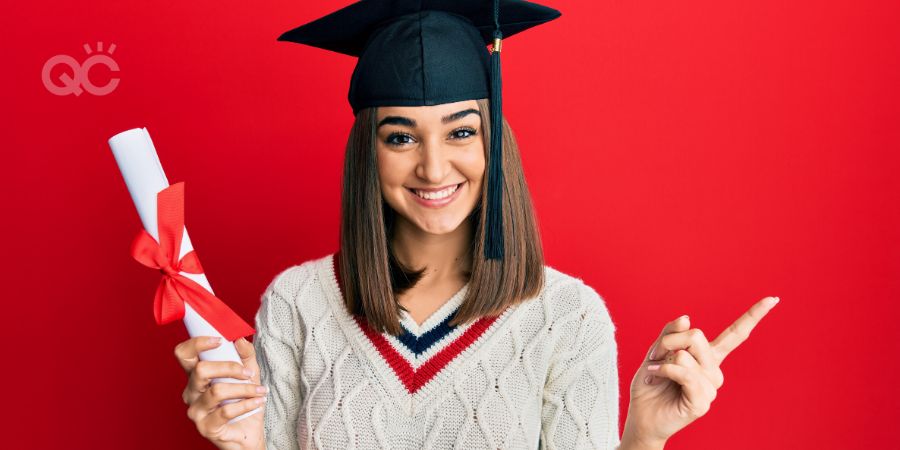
[338,99,544,336]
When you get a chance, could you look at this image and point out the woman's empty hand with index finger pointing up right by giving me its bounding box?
[622,297,778,448]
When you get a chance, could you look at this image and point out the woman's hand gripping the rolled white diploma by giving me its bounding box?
[175,336,266,450]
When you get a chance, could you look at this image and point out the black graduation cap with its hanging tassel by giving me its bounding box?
[278,0,561,260]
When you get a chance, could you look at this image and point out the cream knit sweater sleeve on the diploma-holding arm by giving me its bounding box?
[253,268,303,450]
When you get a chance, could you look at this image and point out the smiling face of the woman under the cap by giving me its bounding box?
[376,100,485,234]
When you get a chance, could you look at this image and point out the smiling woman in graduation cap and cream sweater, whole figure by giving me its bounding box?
[175,0,777,450]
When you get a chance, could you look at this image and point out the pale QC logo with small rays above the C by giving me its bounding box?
[41,42,119,96]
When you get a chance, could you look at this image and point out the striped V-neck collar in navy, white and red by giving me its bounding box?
[320,252,518,415]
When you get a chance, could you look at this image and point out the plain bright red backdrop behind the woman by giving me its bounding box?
[0,0,900,449]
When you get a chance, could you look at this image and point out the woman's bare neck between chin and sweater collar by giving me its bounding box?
[391,215,473,283]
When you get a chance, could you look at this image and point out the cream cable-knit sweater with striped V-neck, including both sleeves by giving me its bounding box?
[254,254,620,450]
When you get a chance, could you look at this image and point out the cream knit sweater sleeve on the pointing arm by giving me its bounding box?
[540,282,621,450]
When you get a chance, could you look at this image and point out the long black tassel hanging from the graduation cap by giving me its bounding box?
[484,0,504,261]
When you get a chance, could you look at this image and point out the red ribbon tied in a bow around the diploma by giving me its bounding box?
[131,182,256,341]
